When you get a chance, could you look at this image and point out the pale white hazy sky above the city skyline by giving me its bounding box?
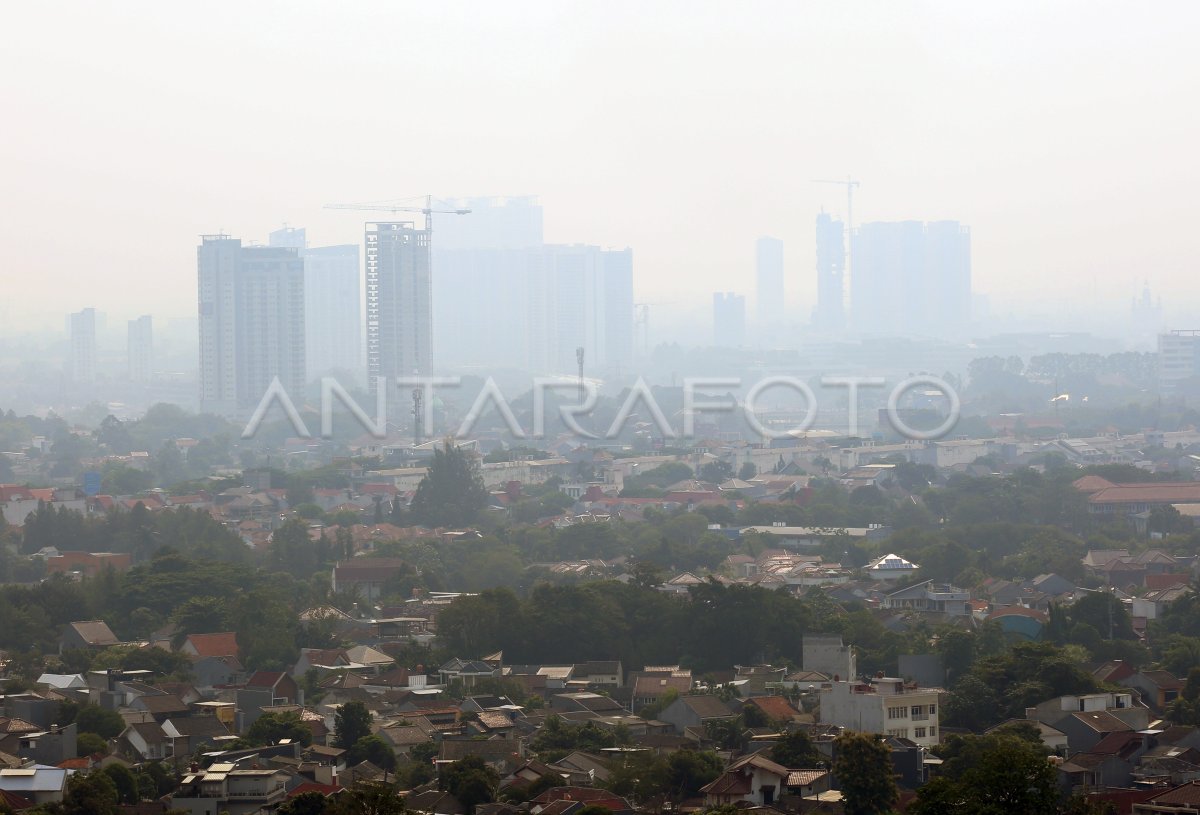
[0,0,1200,331]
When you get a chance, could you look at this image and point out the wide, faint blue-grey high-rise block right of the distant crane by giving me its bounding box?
[850,221,971,337]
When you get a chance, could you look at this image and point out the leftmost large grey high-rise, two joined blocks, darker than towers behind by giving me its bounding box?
[197,235,305,415]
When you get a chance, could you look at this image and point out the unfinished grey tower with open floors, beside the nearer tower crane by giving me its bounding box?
[365,221,433,390]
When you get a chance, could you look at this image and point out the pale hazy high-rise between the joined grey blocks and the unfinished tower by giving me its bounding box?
[270,227,362,385]
